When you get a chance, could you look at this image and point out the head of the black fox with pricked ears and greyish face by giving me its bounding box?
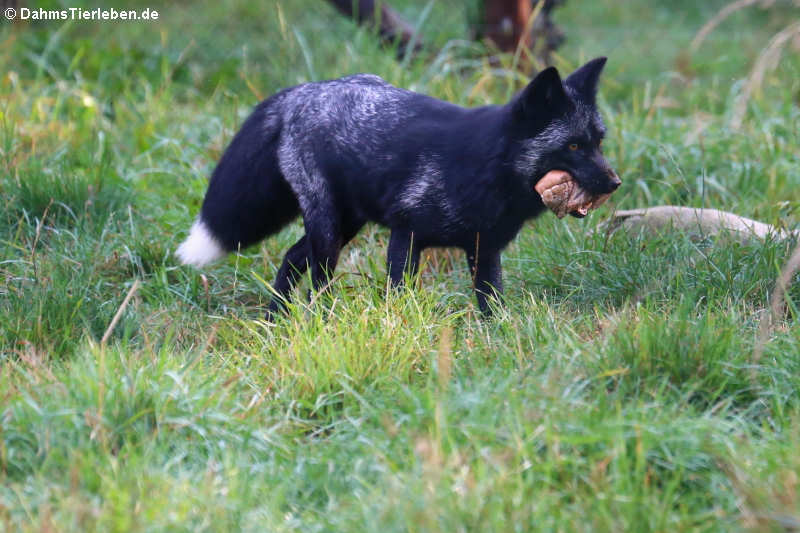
[510,57,622,214]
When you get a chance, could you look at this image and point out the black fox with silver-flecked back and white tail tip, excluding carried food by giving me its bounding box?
[177,58,620,312]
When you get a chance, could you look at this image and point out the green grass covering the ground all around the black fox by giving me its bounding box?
[0,0,800,532]
